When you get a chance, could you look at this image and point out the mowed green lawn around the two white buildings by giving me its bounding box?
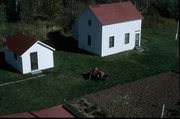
[0,25,179,115]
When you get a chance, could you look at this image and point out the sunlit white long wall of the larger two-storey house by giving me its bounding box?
[101,20,142,56]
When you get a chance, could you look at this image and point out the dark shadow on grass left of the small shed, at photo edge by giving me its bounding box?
[0,52,19,73]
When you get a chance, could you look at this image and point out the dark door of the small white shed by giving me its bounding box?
[30,52,38,70]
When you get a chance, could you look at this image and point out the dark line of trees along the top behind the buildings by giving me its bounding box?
[0,0,179,27]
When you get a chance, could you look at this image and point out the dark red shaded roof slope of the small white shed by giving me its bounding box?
[4,33,37,55]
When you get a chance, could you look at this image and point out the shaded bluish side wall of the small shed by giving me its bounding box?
[5,48,23,73]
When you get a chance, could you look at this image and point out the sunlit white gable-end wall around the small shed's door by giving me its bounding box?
[22,42,54,74]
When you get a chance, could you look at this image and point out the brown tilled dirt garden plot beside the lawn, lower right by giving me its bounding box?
[70,72,179,118]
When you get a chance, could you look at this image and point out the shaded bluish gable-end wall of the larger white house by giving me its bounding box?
[76,8,102,55]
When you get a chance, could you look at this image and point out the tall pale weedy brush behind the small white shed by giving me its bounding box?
[0,20,61,45]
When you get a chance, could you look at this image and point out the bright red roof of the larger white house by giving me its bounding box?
[89,2,143,25]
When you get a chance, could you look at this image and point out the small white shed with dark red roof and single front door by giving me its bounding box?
[4,33,55,74]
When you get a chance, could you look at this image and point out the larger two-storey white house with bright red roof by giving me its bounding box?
[73,2,143,56]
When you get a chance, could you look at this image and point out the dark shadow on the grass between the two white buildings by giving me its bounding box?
[43,31,93,55]
